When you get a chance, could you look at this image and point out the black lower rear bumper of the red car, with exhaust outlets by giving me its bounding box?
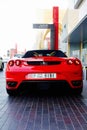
[6,80,83,90]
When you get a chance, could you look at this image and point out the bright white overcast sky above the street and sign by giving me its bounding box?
[0,0,67,55]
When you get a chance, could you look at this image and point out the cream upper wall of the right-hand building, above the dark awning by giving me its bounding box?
[61,9,79,39]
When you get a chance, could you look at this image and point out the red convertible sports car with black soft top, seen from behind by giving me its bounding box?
[6,50,83,95]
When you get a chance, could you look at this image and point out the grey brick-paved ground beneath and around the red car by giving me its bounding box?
[0,66,87,130]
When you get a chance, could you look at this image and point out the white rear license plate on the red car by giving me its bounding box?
[26,73,56,79]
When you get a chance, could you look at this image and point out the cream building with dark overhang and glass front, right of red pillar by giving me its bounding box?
[60,0,87,65]
